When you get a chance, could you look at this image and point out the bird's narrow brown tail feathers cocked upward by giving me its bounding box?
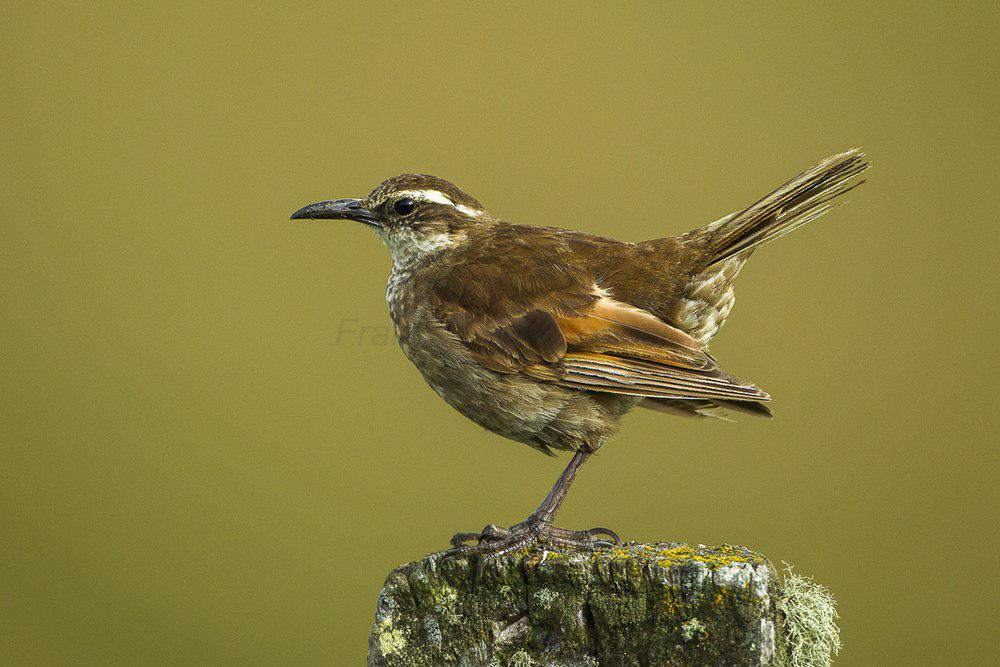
[707,148,871,266]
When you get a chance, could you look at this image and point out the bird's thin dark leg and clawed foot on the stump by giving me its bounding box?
[448,451,621,556]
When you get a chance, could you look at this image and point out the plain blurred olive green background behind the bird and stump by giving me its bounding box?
[0,2,1000,665]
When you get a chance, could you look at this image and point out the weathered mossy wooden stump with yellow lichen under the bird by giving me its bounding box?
[368,542,820,667]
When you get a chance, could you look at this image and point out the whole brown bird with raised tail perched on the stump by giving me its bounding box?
[292,149,870,555]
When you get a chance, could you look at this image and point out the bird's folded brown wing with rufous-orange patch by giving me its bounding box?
[430,232,769,401]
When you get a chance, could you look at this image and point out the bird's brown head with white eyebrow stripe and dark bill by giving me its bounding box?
[292,174,493,264]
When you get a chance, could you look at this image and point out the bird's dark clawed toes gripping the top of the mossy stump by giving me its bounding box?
[445,516,622,558]
